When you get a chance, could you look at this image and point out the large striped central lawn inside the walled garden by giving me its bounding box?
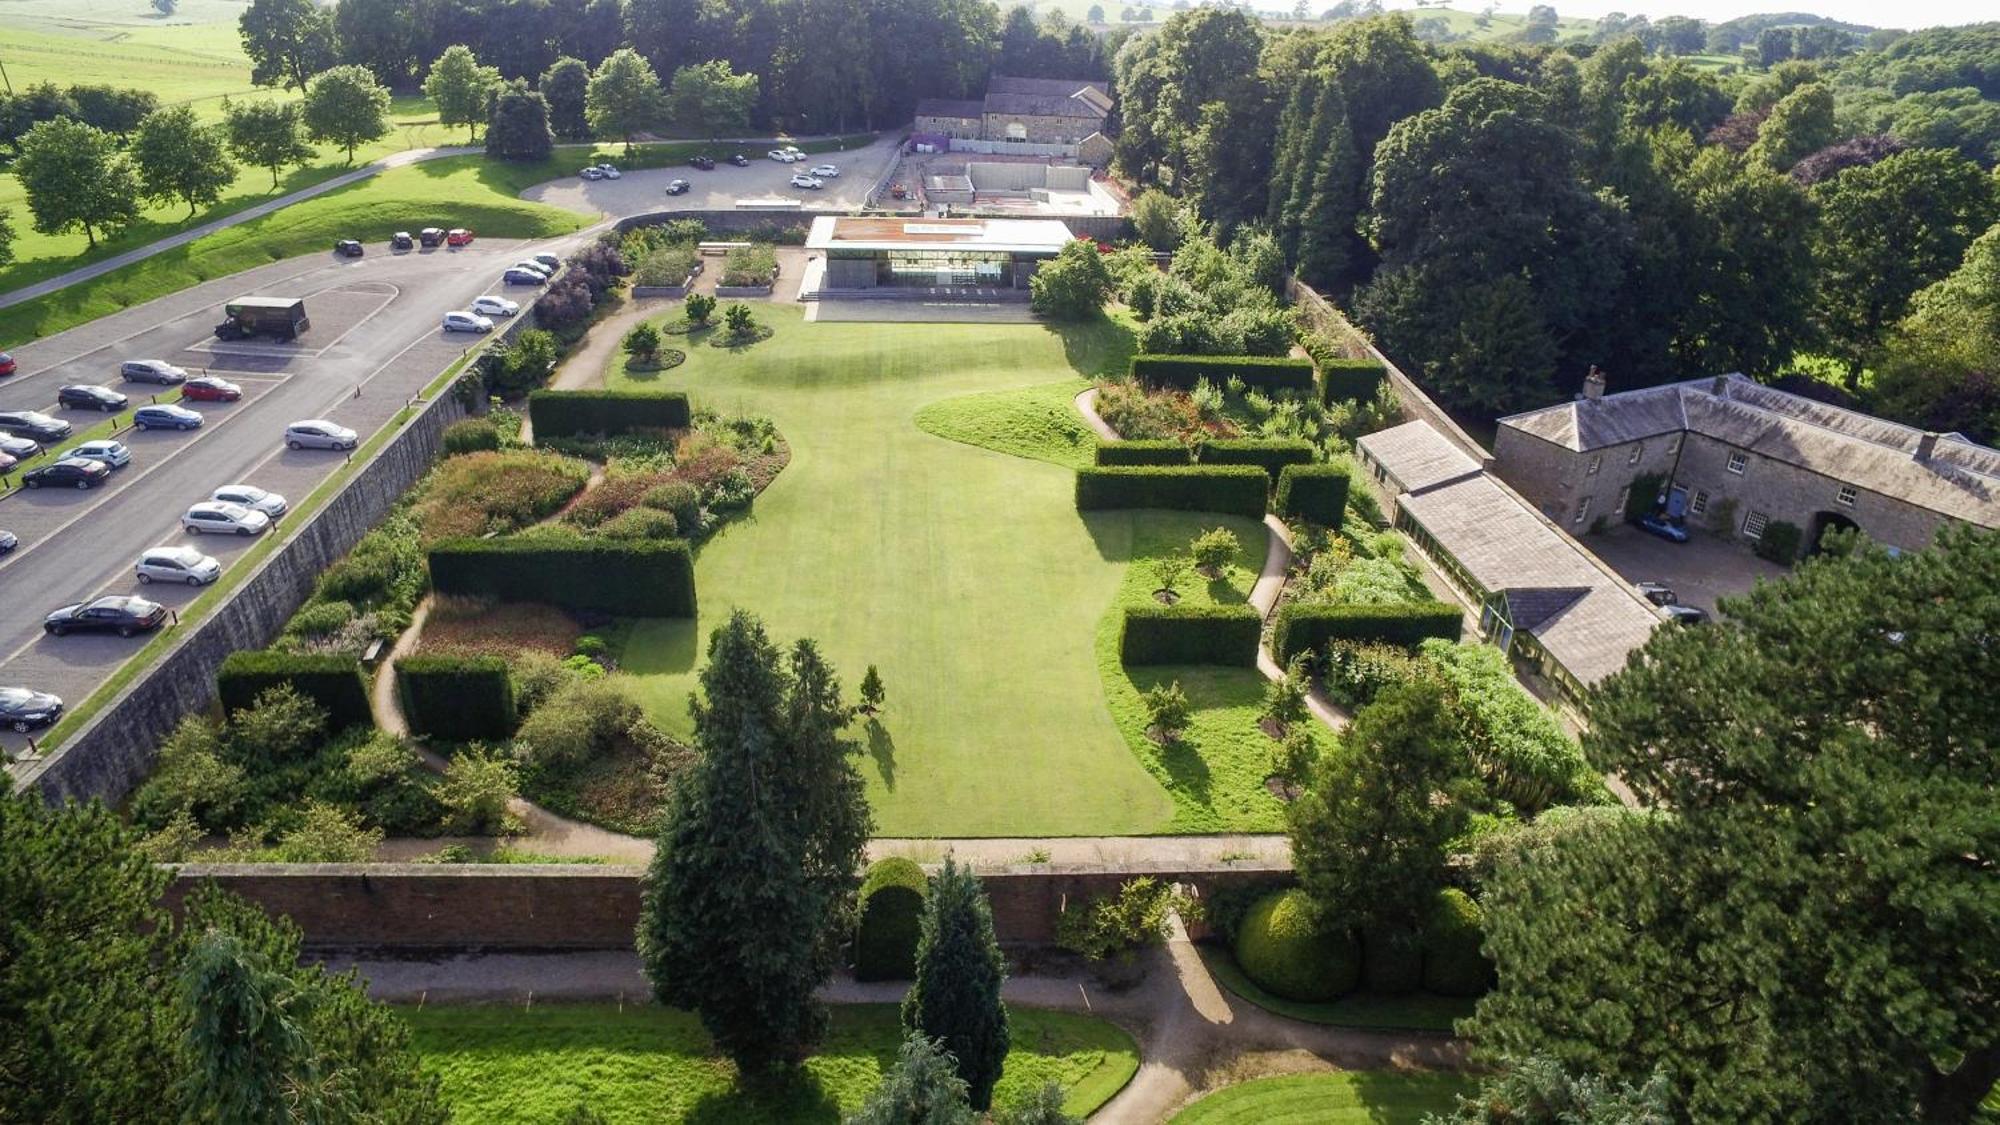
[610,306,1276,837]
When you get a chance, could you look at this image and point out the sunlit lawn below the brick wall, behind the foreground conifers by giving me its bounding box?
[402,1003,1138,1125]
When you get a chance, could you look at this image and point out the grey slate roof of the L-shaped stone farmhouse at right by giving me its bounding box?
[1500,374,2000,526]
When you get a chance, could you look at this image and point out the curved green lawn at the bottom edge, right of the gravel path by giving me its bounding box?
[1172,1071,1472,1125]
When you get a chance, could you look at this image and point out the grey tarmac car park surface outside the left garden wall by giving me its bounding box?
[0,234,584,751]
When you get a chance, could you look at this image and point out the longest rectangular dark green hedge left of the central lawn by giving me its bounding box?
[430,536,694,617]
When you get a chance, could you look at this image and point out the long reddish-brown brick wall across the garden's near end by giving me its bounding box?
[168,863,1292,949]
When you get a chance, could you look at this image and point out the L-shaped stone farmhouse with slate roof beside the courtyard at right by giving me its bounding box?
[1494,372,2000,550]
